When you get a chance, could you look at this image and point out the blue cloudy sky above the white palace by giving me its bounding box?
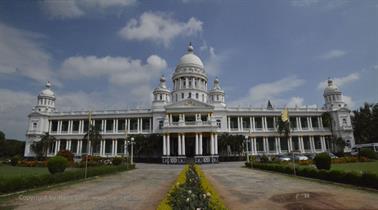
[0,0,378,140]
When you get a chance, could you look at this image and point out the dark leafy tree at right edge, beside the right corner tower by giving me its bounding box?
[352,103,378,144]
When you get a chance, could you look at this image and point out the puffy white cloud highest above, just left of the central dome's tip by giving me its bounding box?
[119,12,203,47]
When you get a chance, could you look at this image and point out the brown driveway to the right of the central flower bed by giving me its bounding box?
[201,162,378,210]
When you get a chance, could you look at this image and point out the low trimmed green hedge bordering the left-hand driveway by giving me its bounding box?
[0,165,135,194]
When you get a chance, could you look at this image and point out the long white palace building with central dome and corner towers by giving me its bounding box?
[25,45,354,164]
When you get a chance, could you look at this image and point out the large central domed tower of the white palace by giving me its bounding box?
[172,43,208,103]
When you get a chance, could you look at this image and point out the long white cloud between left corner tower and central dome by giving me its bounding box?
[60,55,167,86]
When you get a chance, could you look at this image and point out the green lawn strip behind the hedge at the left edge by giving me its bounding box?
[0,165,76,177]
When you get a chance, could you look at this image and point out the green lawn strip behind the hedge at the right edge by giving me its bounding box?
[331,161,378,174]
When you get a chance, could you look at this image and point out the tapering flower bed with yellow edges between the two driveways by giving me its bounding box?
[158,165,226,210]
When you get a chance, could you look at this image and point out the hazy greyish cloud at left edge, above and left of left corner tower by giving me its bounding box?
[0,23,52,81]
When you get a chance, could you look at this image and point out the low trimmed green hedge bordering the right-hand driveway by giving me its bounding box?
[246,163,378,189]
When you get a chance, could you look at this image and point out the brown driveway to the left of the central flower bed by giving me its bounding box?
[0,164,182,210]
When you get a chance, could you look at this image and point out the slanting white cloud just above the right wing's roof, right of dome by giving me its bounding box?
[232,76,305,106]
